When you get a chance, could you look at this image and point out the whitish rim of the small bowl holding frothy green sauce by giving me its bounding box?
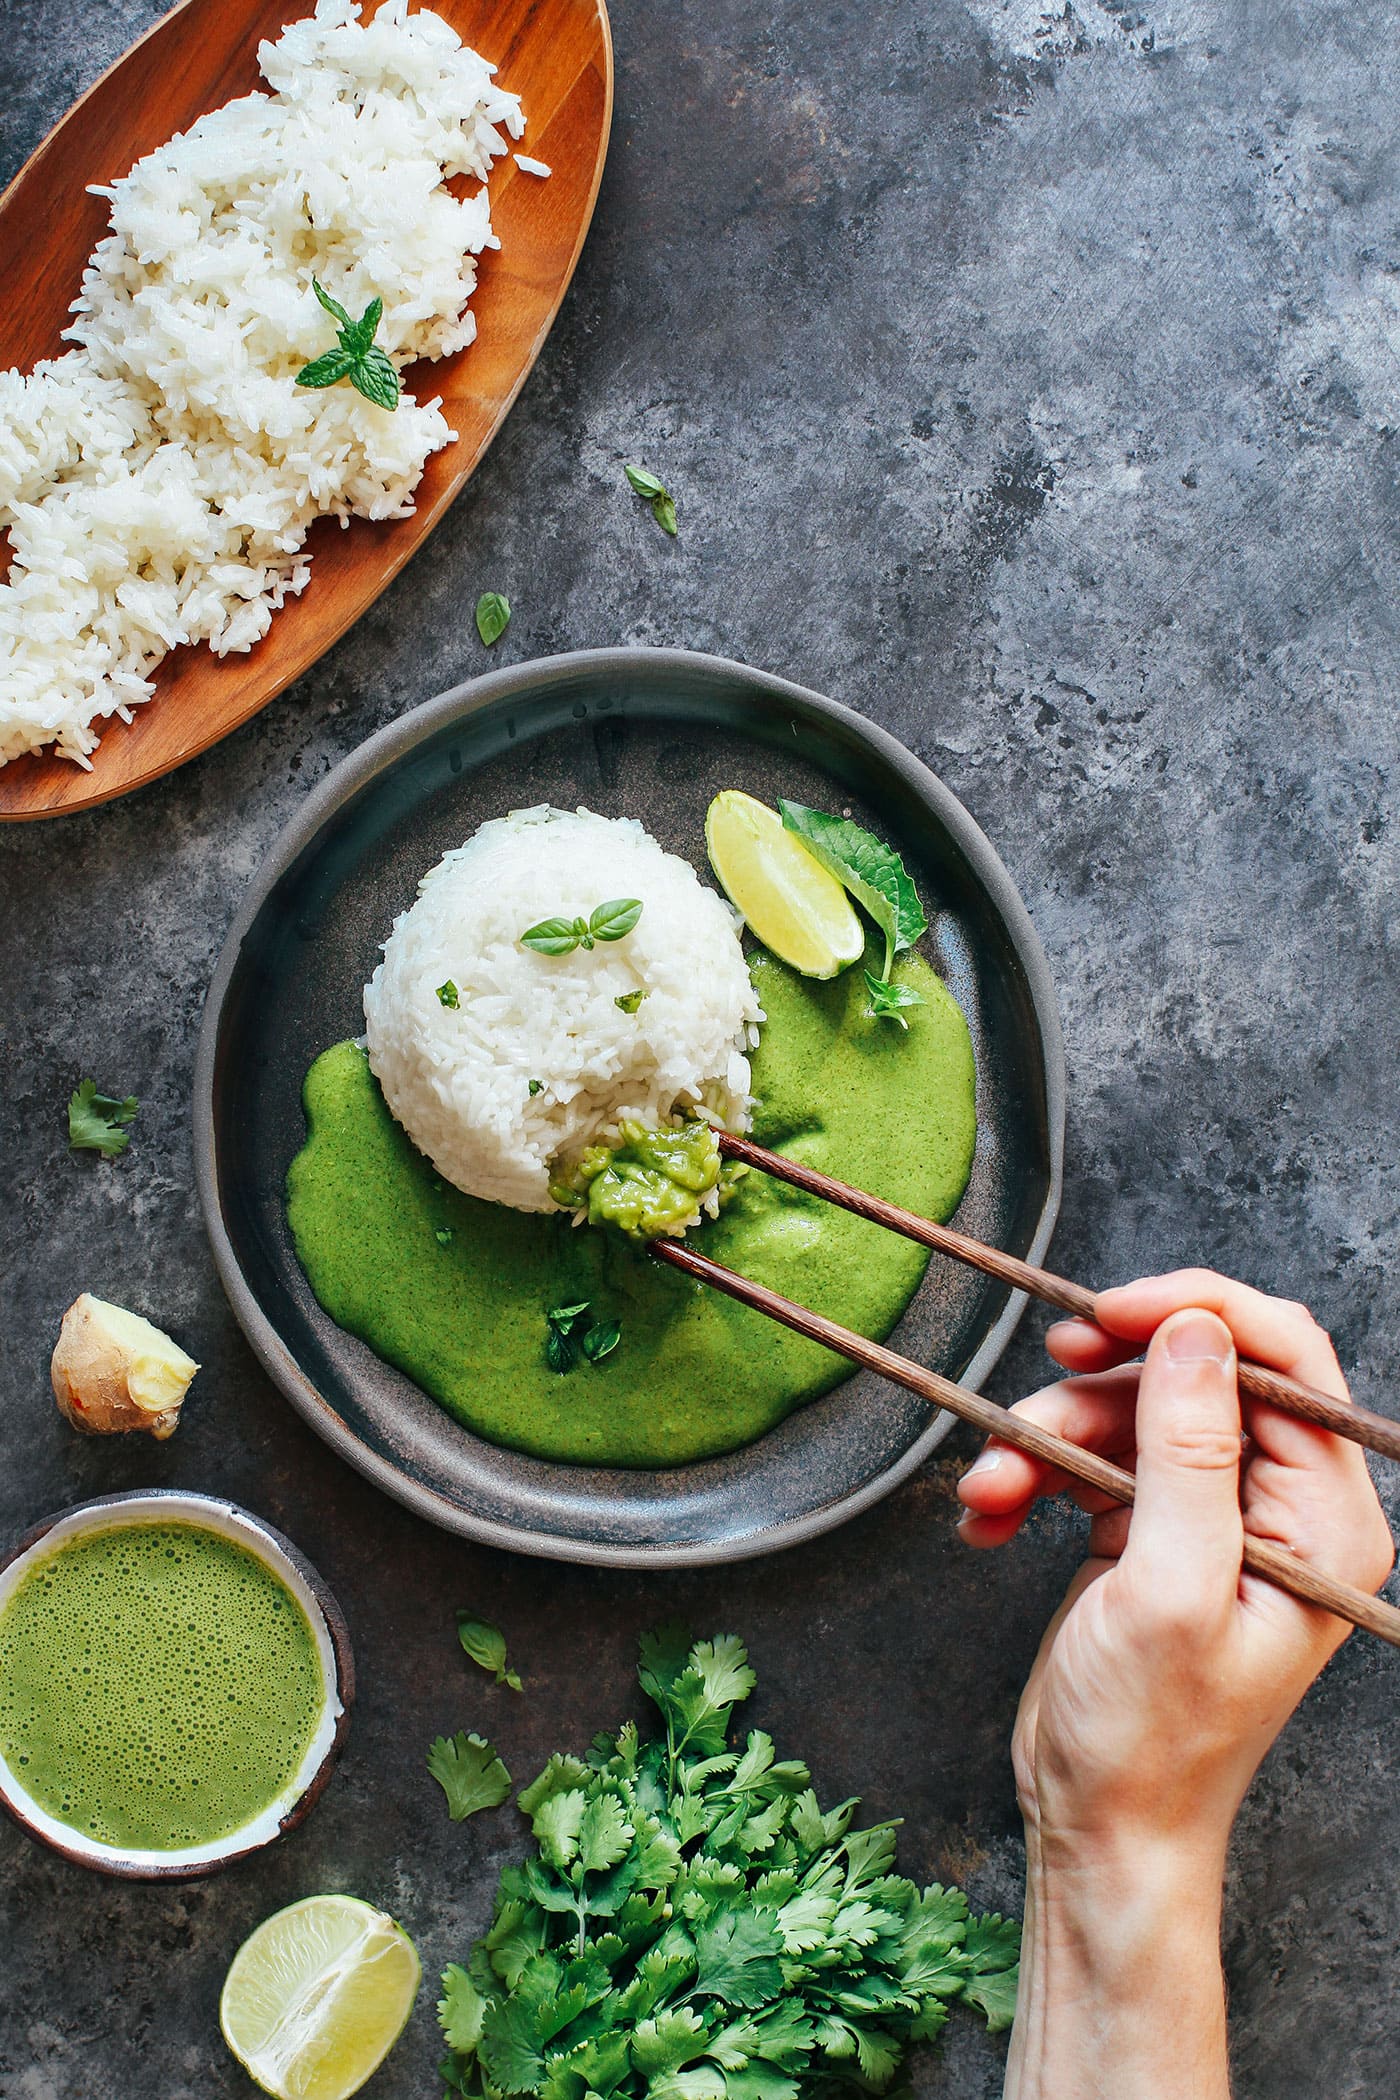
[0,1487,355,1882]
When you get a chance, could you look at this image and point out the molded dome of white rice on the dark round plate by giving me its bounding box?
[365,809,764,1210]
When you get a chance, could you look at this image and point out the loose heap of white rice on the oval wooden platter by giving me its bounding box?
[0,0,525,764]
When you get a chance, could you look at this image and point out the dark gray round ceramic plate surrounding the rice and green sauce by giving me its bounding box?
[195,649,1064,1567]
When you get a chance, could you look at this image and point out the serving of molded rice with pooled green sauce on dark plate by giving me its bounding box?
[288,793,976,1466]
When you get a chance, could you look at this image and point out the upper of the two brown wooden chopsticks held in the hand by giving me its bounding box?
[716,1130,1400,1460]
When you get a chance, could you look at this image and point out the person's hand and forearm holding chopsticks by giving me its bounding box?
[959,1271,1394,2100]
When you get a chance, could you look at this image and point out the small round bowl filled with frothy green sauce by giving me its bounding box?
[0,1493,348,1873]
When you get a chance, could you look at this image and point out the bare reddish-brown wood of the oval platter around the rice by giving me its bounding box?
[0,0,613,819]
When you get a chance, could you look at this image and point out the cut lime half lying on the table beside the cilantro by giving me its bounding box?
[218,1896,422,2100]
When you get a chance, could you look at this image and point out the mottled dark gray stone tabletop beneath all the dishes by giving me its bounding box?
[0,0,1400,2100]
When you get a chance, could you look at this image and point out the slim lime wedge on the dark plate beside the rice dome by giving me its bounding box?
[705,788,865,977]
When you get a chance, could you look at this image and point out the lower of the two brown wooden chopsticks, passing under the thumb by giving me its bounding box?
[651,1239,1400,1649]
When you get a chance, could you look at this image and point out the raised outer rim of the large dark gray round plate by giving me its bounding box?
[193,647,1066,1569]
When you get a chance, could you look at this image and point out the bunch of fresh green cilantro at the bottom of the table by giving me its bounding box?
[439,1630,1020,2100]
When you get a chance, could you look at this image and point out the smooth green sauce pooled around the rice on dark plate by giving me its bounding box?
[288,951,976,1466]
